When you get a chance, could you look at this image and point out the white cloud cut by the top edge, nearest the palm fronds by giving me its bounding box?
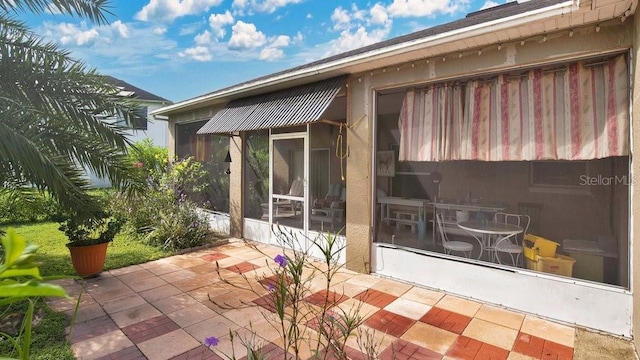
[135,0,222,22]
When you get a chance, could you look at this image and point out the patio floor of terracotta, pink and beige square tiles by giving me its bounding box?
[50,241,636,360]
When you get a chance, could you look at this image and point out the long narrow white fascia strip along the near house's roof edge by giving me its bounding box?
[151,0,579,115]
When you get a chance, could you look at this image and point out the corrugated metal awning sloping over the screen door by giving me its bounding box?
[198,76,347,134]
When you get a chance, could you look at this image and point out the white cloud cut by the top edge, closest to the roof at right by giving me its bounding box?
[387,0,469,17]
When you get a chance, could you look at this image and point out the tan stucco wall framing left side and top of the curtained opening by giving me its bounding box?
[347,21,640,271]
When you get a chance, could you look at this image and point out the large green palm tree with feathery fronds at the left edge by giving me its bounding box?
[0,0,141,218]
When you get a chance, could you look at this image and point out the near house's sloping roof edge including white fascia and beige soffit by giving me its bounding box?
[152,0,635,114]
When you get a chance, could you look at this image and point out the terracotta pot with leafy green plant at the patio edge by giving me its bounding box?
[60,212,123,277]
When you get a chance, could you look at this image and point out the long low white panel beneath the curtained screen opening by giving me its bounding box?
[372,244,633,338]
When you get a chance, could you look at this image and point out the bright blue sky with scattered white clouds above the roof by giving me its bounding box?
[27,0,497,102]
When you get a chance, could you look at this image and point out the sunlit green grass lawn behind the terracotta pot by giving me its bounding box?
[2,222,171,276]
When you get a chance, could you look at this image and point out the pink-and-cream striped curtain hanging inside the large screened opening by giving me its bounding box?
[399,55,629,161]
